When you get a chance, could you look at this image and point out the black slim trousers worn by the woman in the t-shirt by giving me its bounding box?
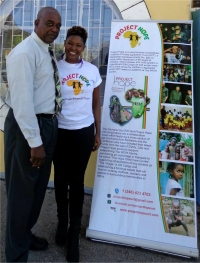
[53,124,94,227]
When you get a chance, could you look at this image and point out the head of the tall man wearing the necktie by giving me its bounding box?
[35,10,61,44]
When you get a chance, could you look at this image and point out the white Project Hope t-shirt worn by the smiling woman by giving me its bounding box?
[57,60,102,130]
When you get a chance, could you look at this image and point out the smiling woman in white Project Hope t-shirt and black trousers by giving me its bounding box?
[53,26,102,262]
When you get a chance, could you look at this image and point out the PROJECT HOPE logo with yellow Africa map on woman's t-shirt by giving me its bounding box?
[62,73,91,95]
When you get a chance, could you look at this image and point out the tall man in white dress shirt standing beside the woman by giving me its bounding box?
[4,7,61,262]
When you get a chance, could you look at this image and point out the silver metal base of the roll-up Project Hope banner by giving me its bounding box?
[86,228,199,257]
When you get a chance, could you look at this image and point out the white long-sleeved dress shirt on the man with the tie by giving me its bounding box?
[6,32,55,148]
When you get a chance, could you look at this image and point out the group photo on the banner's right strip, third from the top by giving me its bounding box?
[163,64,192,83]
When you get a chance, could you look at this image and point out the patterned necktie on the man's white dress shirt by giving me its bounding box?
[49,46,62,113]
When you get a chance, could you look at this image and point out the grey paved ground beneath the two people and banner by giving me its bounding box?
[0,180,200,263]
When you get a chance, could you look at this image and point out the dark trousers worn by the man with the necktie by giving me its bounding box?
[4,109,58,262]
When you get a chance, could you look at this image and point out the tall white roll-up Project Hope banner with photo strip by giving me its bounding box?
[86,20,199,257]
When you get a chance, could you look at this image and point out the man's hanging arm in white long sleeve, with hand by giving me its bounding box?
[7,53,45,166]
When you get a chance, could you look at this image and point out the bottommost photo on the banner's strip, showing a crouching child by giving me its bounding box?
[162,196,195,237]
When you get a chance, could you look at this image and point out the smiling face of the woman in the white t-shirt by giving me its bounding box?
[64,36,85,64]
